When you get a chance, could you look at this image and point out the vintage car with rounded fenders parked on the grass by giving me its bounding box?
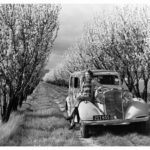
[66,70,149,138]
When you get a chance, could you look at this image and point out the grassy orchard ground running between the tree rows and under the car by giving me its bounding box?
[0,83,150,146]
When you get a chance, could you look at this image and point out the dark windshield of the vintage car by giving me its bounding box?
[94,75,119,85]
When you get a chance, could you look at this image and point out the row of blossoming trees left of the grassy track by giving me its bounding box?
[0,4,60,122]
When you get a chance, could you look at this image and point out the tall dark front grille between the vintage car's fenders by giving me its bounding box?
[104,89,123,119]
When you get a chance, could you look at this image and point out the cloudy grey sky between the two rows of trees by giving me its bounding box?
[46,4,112,70]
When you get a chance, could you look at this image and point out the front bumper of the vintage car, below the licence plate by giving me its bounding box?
[81,116,149,126]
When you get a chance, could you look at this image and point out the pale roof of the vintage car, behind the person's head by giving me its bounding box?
[71,69,119,77]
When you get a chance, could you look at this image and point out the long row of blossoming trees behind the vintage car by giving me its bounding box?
[47,5,150,101]
